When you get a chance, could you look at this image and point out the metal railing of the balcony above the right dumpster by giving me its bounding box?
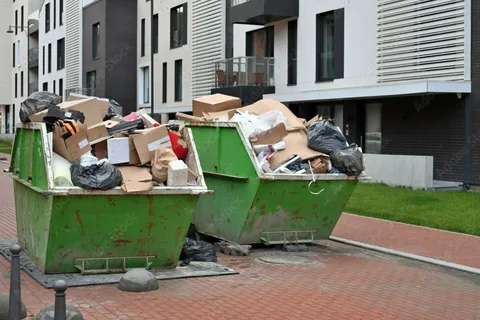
[215,57,275,88]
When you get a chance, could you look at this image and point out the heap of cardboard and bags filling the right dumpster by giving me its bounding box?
[177,94,366,176]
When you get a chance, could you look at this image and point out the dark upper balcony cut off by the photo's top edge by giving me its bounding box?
[229,0,299,25]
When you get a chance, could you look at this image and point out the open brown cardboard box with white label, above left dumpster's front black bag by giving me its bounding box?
[53,124,92,162]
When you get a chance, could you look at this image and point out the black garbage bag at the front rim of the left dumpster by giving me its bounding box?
[70,161,122,190]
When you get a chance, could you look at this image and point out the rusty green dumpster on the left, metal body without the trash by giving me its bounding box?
[9,123,211,273]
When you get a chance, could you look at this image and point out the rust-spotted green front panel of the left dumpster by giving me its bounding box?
[44,194,199,273]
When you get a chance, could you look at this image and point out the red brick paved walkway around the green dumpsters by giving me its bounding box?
[0,154,480,320]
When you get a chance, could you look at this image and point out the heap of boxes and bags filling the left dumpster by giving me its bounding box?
[20,92,197,193]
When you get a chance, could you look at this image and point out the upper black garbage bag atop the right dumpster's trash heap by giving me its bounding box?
[308,119,347,154]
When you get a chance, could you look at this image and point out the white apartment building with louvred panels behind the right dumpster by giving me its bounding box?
[219,0,480,187]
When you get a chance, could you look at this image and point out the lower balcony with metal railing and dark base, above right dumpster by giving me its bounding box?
[211,57,275,105]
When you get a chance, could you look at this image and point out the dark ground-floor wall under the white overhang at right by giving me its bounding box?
[382,94,466,182]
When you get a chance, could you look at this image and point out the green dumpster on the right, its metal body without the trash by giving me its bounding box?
[187,122,358,245]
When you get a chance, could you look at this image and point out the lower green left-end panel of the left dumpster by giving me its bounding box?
[13,180,52,269]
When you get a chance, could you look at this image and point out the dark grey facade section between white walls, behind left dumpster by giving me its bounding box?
[82,0,106,97]
